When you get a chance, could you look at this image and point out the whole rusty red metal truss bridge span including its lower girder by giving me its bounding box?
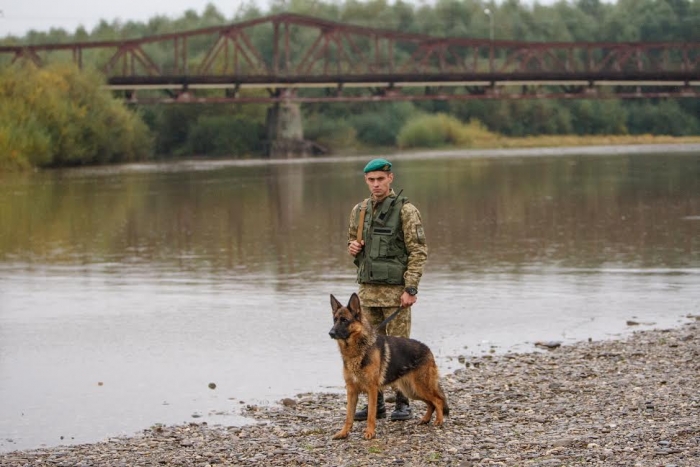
[0,13,700,103]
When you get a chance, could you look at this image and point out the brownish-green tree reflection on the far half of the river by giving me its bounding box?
[0,155,700,274]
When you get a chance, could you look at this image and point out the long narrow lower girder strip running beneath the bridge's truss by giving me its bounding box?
[112,74,700,103]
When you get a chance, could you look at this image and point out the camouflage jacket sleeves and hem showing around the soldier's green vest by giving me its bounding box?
[348,190,428,307]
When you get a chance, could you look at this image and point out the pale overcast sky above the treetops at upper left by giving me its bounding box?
[0,0,554,37]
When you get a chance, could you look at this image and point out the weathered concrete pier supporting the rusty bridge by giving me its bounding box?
[266,89,311,159]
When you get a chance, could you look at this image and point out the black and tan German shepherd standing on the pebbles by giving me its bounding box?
[329,294,449,439]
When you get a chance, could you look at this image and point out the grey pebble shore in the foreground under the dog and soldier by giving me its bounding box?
[0,317,700,467]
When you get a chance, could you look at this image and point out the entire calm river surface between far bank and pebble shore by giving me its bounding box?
[0,150,700,450]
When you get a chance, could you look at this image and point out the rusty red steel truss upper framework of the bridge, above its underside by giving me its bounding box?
[0,13,700,98]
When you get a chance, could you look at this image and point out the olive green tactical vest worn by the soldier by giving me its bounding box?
[355,196,408,285]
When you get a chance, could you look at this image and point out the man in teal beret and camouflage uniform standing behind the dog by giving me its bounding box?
[348,159,428,420]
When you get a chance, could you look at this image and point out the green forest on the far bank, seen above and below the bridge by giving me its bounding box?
[0,0,700,170]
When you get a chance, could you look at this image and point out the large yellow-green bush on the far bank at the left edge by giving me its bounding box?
[0,64,151,170]
